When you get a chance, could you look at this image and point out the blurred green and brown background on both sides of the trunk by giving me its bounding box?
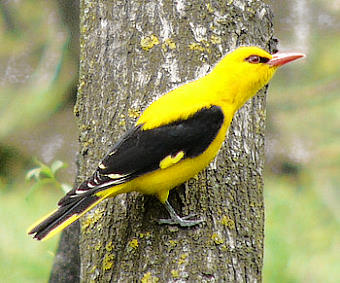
[0,0,340,282]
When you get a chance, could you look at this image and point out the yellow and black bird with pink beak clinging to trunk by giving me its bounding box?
[28,46,305,240]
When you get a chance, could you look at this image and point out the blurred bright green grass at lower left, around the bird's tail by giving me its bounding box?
[0,180,62,283]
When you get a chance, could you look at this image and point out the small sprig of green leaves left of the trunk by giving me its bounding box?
[26,159,72,197]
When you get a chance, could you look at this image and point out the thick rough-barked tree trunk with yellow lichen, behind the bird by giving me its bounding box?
[71,0,275,282]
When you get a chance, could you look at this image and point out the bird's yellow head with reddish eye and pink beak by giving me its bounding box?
[212,46,305,108]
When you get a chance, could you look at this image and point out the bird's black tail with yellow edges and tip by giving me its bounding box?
[28,190,112,240]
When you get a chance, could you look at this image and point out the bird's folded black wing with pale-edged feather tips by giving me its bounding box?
[59,106,224,204]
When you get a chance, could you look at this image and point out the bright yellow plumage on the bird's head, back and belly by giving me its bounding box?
[132,47,276,202]
